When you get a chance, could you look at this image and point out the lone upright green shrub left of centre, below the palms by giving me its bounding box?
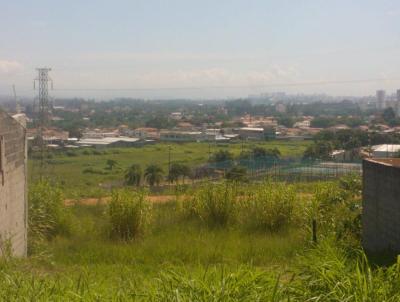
[108,189,152,240]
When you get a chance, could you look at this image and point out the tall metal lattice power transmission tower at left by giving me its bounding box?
[33,67,53,173]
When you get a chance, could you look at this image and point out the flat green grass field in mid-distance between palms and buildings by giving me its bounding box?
[29,141,310,198]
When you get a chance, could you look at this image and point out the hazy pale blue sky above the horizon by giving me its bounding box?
[0,0,400,98]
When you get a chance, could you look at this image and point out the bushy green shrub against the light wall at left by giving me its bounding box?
[28,181,69,253]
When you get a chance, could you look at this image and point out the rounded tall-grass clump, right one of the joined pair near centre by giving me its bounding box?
[241,182,299,232]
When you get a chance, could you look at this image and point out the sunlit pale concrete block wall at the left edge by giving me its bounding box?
[0,111,27,256]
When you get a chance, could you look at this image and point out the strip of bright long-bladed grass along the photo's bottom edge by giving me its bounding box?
[0,241,400,302]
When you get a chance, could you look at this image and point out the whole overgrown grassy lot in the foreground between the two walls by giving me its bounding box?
[0,178,400,301]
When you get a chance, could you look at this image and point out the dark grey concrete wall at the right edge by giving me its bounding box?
[362,159,400,252]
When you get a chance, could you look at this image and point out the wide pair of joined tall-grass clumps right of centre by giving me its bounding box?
[180,182,302,232]
